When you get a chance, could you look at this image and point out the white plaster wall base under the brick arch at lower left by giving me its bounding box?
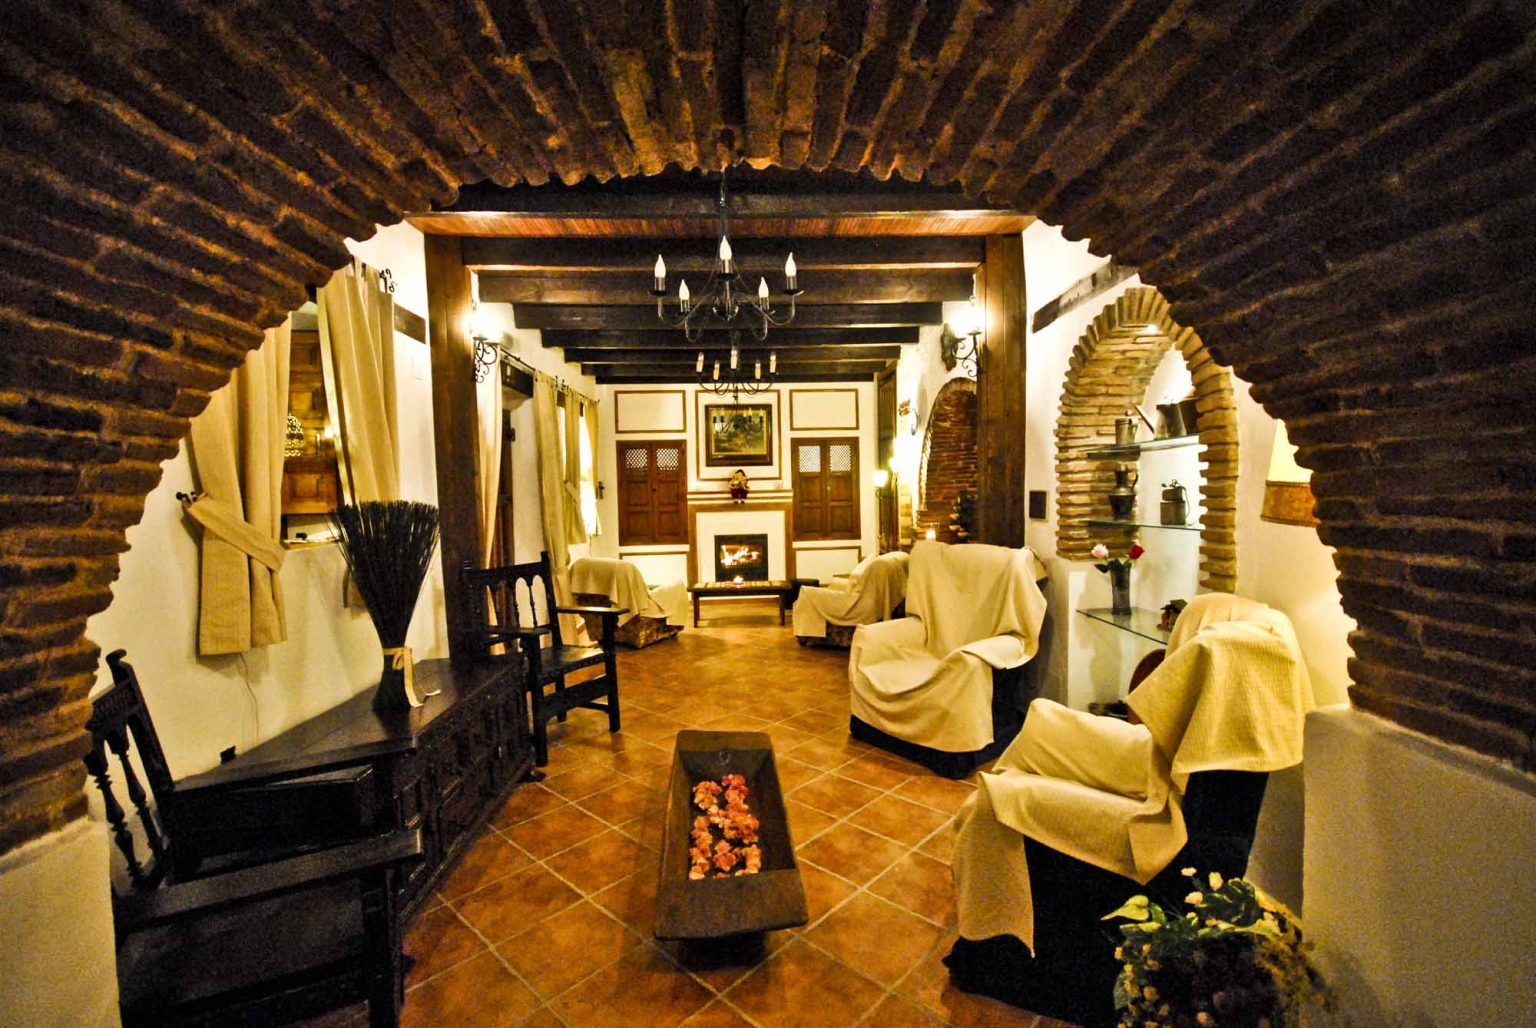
[0,817,118,1028]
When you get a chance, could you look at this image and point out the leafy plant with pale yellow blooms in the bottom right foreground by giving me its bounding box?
[1104,868,1332,1028]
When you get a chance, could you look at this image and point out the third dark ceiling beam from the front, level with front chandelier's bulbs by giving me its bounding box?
[479,267,974,310]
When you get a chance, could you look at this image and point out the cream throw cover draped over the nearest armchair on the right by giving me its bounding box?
[952,593,1313,950]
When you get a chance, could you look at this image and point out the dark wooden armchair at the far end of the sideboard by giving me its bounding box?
[462,552,628,767]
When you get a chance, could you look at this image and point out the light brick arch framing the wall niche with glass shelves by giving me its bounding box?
[1057,286,1238,592]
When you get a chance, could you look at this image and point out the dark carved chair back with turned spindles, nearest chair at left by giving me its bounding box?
[84,650,175,888]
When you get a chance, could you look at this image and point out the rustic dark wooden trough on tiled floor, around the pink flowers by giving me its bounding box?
[656,731,809,939]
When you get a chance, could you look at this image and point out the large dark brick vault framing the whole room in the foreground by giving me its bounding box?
[0,0,1536,850]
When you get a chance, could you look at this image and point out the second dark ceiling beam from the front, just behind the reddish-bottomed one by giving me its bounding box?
[464,235,985,274]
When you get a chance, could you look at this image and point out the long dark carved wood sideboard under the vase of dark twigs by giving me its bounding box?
[177,659,533,922]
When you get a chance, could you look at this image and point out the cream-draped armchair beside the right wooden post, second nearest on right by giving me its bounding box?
[848,541,1046,778]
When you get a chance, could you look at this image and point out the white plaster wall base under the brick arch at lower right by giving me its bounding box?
[1304,708,1536,1028]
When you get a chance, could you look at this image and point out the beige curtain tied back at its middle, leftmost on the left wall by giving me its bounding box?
[186,324,290,656]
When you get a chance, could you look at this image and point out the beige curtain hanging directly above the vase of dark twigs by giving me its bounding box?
[315,264,399,502]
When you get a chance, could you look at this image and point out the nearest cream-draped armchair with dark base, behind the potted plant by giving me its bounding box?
[945,593,1313,1028]
